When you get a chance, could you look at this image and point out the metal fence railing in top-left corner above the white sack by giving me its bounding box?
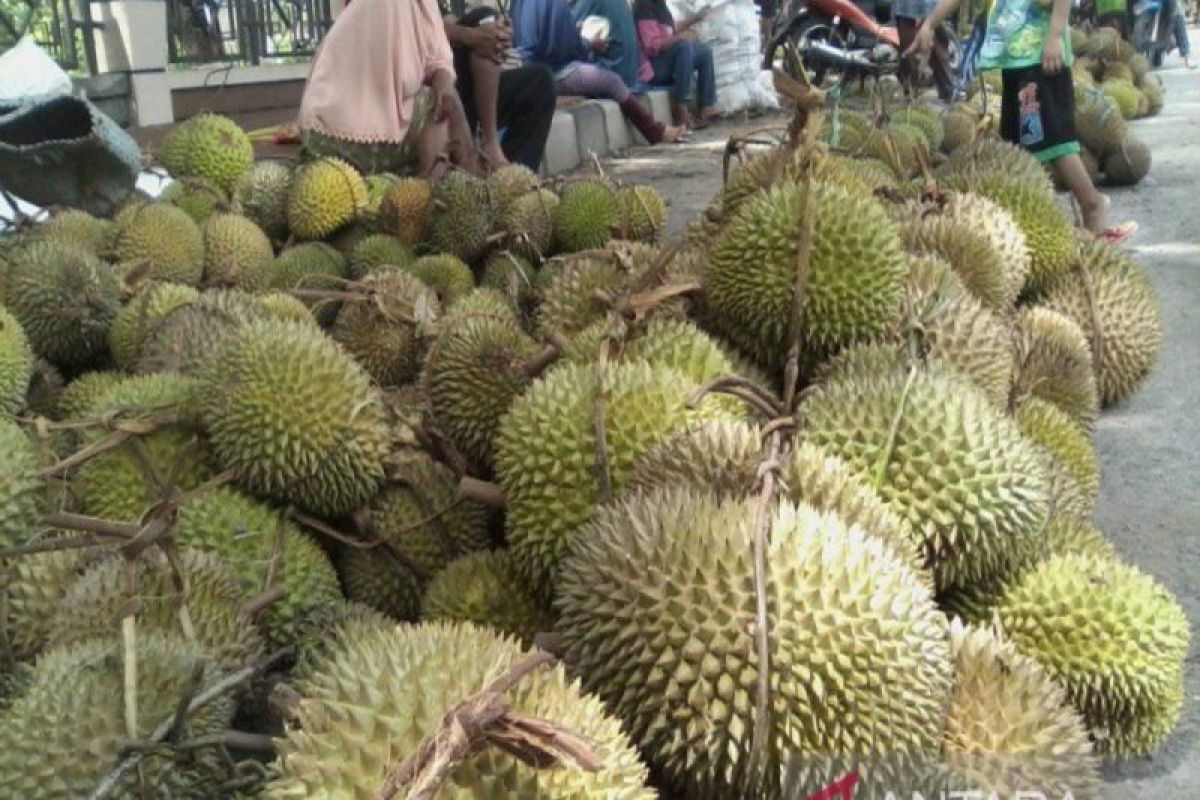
[0,0,96,73]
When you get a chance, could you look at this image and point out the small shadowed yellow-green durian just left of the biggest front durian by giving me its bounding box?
[421,551,554,646]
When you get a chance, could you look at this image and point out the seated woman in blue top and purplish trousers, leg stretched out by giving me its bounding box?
[513,0,685,144]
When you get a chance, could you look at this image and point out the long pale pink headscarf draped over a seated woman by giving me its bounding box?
[299,0,454,144]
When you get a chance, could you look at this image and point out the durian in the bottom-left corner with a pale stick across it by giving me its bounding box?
[0,631,235,800]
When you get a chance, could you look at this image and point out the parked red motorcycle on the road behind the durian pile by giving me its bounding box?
[763,0,962,90]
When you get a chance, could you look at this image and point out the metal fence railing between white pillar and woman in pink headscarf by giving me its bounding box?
[166,0,334,64]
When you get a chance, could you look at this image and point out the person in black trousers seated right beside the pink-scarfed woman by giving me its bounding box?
[445,7,554,172]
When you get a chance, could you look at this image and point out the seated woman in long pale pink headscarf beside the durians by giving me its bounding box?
[299,0,479,174]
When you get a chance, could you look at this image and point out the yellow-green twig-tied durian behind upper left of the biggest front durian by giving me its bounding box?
[496,361,732,591]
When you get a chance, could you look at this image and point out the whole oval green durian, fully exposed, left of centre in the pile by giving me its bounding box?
[197,320,388,516]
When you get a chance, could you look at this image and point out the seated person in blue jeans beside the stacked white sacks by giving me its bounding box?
[634,0,716,127]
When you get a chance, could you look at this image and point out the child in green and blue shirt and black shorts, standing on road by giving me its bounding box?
[908,0,1129,241]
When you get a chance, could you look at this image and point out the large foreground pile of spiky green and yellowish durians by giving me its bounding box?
[0,109,1189,800]
